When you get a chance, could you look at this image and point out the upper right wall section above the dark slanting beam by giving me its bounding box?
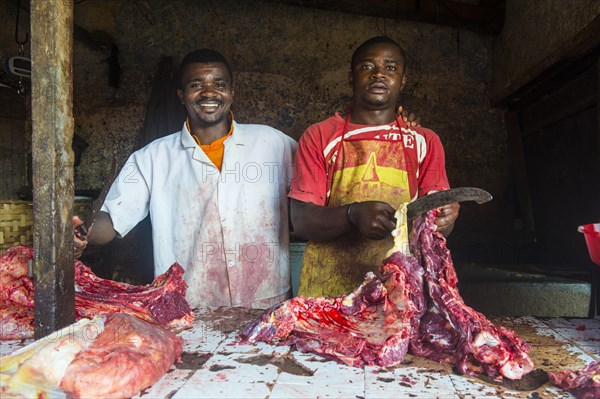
[491,0,600,102]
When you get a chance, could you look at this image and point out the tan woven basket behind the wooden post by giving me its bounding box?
[0,201,91,251]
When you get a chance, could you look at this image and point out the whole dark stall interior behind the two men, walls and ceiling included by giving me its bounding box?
[0,0,600,294]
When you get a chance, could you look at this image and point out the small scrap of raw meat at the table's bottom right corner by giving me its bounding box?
[548,360,600,399]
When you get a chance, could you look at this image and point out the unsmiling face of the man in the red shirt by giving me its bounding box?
[349,43,406,110]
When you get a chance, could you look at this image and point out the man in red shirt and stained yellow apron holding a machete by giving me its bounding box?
[288,37,459,296]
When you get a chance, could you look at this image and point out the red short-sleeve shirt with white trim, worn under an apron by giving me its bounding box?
[288,113,450,205]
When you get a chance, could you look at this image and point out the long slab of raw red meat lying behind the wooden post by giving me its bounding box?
[0,246,194,340]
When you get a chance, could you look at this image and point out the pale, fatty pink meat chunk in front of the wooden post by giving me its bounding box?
[0,313,182,398]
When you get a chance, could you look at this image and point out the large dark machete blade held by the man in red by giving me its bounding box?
[406,187,492,219]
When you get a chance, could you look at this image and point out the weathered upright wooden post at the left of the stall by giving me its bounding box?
[31,0,75,339]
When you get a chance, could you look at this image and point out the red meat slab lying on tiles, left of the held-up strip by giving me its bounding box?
[240,253,424,367]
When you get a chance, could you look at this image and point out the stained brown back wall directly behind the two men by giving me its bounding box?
[0,0,512,258]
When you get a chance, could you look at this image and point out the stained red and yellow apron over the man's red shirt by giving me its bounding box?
[298,116,411,296]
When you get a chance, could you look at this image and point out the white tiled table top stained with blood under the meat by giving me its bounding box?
[0,309,600,399]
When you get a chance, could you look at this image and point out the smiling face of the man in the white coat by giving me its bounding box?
[177,62,233,126]
